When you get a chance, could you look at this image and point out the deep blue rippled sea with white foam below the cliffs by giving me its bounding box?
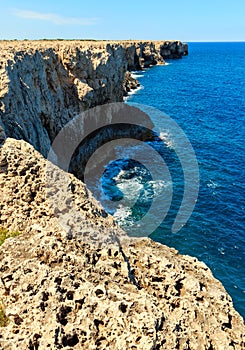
[103,43,245,318]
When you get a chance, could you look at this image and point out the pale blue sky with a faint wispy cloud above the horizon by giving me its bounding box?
[0,0,245,42]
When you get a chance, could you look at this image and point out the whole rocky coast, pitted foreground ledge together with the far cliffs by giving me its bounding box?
[0,41,245,350]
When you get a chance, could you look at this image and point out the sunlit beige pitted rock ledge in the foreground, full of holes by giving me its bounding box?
[0,139,245,350]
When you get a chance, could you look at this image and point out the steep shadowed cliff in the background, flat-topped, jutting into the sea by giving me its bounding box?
[0,41,187,156]
